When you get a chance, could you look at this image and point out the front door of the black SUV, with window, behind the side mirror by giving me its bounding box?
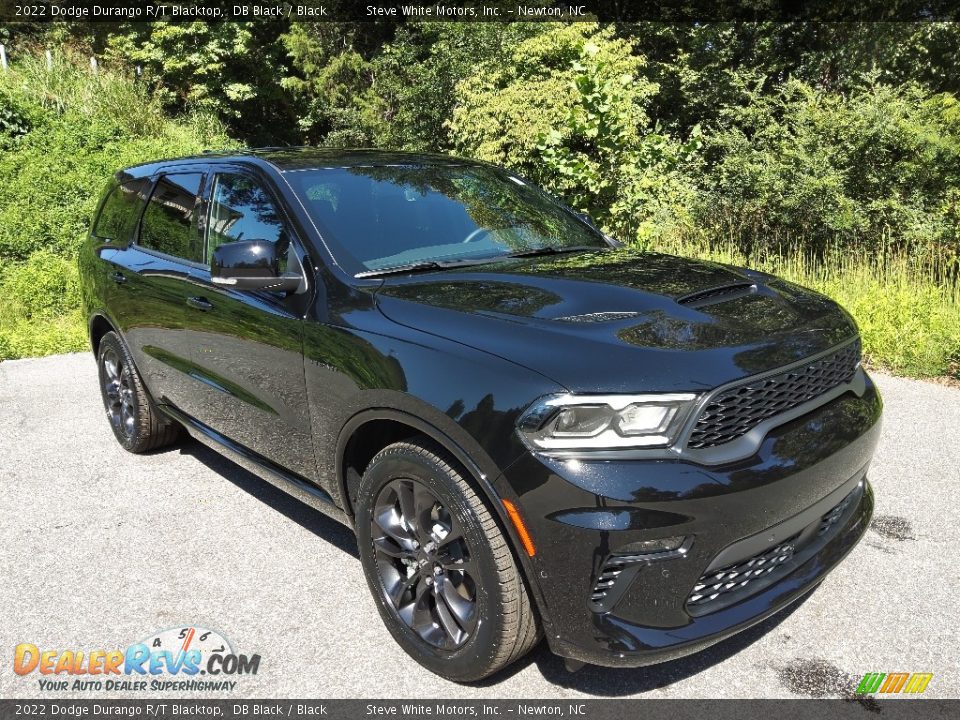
[178,165,316,480]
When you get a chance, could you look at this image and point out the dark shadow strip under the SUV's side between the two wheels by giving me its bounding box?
[178,440,360,560]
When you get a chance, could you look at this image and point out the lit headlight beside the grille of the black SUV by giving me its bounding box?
[517,393,697,451]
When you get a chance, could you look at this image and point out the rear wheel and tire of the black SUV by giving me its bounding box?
[97,332,180,453]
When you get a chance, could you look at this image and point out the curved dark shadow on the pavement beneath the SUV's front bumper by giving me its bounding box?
[479,586,819,697]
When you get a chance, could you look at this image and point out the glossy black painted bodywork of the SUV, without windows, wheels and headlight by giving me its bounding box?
[80,151,881,665]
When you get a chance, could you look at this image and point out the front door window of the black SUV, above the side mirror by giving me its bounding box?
[207,173,290,263]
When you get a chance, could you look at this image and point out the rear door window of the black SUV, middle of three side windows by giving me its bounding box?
[138,173,203,262]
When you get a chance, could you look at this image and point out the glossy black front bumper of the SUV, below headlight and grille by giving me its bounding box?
[505,383,882,665]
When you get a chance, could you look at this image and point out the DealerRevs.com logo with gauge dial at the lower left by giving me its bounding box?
[13,626,260,692]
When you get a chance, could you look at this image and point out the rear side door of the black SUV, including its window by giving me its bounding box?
[109,165,212,413]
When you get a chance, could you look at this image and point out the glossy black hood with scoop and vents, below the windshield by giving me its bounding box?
[376,249,856,392]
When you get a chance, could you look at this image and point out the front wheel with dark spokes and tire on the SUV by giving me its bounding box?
[356,437,540,682]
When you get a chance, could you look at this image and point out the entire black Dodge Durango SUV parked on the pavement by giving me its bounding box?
[80,149,881,681]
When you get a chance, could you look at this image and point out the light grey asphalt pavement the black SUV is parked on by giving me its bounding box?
[0,354,960,699]
